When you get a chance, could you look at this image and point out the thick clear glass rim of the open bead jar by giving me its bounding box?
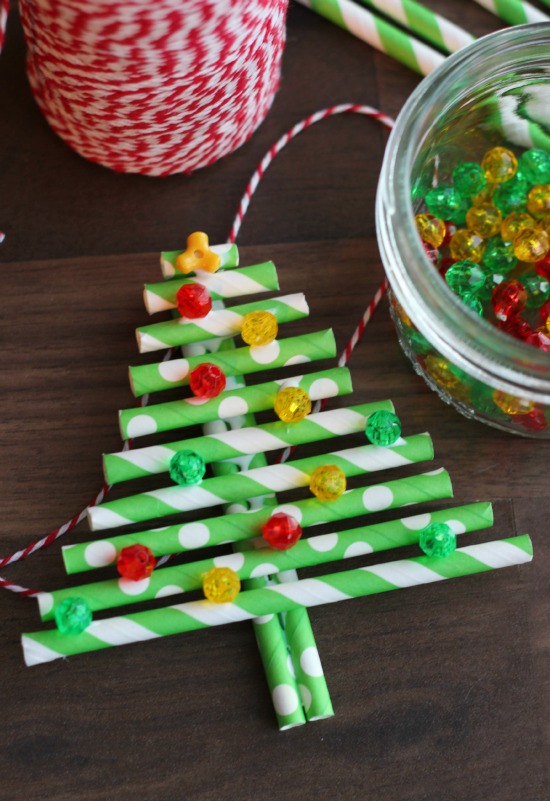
[376,22,550,394]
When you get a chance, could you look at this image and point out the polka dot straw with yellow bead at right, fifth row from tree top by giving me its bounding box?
[119,367,352,439]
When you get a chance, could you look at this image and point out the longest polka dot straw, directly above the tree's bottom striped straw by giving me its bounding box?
[41,502,493,620]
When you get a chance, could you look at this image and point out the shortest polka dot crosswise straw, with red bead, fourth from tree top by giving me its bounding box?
[130,329,336,398]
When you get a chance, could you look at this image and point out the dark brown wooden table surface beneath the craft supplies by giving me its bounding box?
[0,0,550,801]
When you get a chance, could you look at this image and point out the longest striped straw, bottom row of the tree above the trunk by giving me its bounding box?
[22,535,533,666]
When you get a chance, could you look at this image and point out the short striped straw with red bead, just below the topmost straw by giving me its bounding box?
[143,261,279,314]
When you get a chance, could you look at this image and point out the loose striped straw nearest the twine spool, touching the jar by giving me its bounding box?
[298,0,445,75]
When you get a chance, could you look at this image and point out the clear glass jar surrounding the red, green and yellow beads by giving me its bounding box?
[376,23,550,439]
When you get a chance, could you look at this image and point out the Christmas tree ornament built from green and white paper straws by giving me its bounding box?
[23,235,532,729]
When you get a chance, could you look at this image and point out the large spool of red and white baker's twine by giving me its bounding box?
[14,0,288,175]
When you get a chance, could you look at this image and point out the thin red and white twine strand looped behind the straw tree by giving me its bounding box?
[0,103,393,597]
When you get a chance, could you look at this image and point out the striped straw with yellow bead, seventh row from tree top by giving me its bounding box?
[88,434,433,531]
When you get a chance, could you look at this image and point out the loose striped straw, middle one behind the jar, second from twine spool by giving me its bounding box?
[361,0,475,53]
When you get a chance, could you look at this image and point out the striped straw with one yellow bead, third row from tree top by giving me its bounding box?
[136,292,309,353]
